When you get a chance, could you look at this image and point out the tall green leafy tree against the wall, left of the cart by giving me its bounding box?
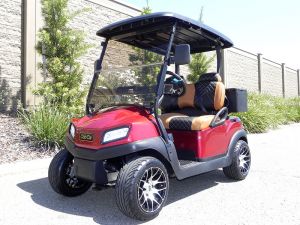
[34,0,91,110]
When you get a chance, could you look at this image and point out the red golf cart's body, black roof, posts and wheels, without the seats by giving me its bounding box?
[49,13,250,220]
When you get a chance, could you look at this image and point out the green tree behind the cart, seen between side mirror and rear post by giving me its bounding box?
[187,7,215,83]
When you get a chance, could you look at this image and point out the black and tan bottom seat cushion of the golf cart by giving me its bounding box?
[160,113,214,130]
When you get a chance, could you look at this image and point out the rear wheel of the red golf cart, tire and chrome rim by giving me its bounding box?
[223,140,251,180]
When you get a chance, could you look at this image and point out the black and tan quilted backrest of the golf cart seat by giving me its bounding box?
[161,73,225,113]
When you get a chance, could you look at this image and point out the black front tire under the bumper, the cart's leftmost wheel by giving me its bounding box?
[48,149,92,197]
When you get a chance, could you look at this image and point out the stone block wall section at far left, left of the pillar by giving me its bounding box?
[0,0,22,111]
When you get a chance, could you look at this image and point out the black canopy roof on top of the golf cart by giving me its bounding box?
[97,12,233,54]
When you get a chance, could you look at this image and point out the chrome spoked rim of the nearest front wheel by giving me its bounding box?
[138,167,167,213]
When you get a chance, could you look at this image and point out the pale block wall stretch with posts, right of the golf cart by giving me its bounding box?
[204,47,300,97]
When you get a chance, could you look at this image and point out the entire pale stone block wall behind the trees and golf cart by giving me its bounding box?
[0,0,300,111]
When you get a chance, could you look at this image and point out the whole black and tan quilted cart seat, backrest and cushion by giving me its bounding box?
[160,73,225,130]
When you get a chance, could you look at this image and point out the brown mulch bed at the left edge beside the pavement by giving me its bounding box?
[0,113,57,164]
